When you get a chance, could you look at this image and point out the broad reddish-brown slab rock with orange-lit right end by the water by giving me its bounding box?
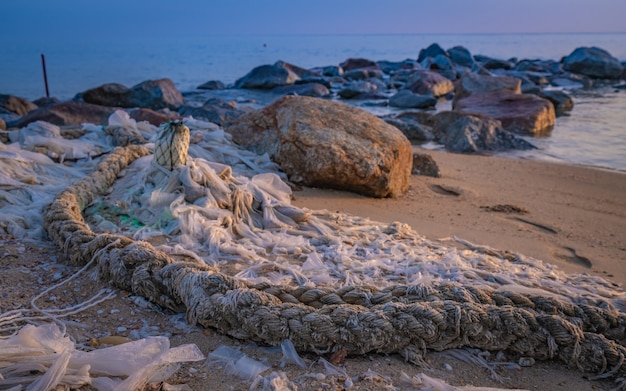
[454,91,556,136]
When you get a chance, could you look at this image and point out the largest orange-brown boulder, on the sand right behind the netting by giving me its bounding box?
[225,96,412,197]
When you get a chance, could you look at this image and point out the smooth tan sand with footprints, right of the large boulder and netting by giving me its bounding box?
[293,147,626,286]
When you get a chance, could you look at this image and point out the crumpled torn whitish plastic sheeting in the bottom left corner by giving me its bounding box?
[0,324,204,391]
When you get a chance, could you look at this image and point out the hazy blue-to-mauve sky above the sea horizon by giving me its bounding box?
[0,0,626,39]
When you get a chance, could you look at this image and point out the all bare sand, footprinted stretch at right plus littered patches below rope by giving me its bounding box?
[0,151,626,391]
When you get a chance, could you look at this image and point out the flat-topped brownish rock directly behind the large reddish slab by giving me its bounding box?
[452,73,522,108]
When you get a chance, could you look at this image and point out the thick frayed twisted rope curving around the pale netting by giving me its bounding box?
[44,146,626,377]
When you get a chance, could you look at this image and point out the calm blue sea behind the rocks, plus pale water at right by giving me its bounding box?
[0,33,626,171]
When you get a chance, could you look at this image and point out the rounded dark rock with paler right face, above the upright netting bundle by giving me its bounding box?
[131,79,184,110]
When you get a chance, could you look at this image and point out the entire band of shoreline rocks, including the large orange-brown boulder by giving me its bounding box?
[0,43,626,197]
